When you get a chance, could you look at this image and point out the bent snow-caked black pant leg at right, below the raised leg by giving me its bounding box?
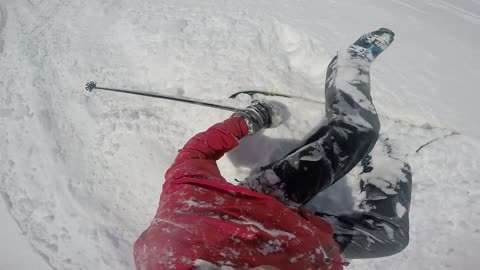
[316,140,412,259]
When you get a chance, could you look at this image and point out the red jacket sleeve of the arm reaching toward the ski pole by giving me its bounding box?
[164,117,248,188]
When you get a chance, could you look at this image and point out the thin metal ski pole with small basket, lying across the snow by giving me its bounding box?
[85,81,243,112]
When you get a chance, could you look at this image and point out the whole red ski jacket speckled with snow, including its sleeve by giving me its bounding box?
[134,117,343,270]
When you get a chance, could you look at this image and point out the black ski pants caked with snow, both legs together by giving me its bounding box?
[244,53,412,259]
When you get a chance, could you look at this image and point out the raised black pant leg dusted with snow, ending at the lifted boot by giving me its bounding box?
[242,50,380,204]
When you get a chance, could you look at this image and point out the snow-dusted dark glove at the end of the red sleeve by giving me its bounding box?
[232,100,283,135]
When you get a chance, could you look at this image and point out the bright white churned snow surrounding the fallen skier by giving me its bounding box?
[0,0,480,270]
